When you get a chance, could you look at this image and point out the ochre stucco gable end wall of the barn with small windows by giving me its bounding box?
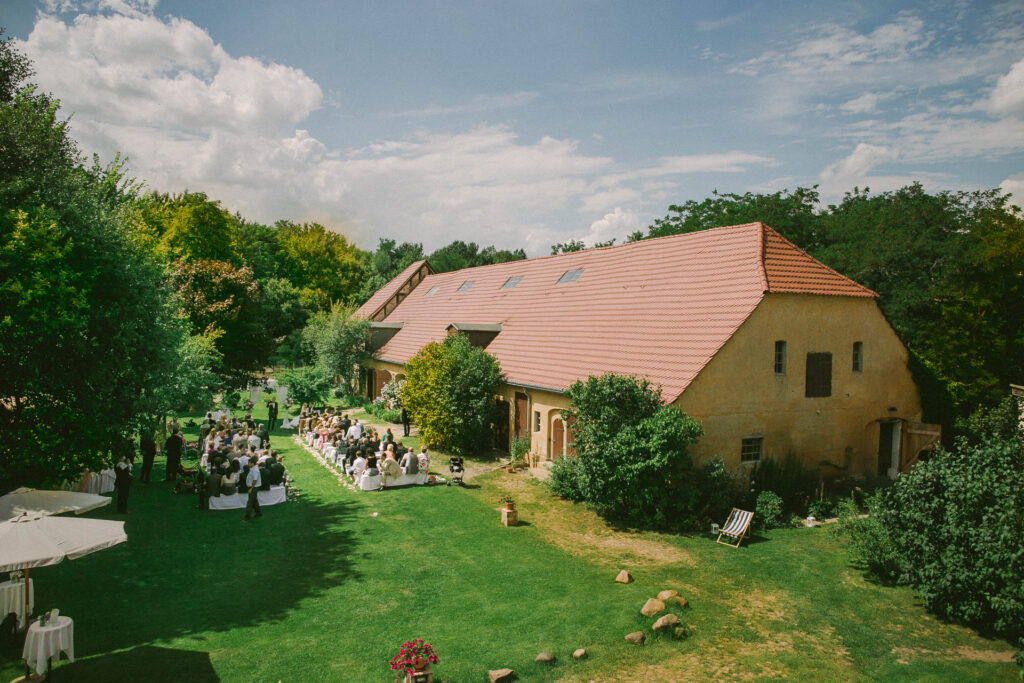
[675,294,921,475]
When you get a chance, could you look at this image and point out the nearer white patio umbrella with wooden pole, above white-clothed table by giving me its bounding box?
[0,515,128,629]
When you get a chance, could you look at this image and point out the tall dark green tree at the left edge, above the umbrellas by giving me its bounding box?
[0,33,181,488]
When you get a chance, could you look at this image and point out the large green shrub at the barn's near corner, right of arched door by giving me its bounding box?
[562,375,701,528]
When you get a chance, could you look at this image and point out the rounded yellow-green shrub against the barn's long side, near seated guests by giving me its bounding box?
[401,335,502,454]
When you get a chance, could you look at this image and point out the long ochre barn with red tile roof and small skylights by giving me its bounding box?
[357,223,939,476]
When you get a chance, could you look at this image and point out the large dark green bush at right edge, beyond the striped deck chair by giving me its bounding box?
[840,428,1024,637]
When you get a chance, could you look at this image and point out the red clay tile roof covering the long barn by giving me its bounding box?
[360,223,874,401]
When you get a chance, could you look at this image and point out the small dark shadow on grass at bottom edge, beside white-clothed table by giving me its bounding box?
[60,645,220,683]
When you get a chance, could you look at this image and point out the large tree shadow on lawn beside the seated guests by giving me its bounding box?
[0,462,359,663]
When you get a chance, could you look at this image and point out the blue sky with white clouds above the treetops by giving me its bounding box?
[8,0,1024,255]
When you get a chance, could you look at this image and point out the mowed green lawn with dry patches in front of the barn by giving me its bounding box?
[0,409,1017,682]
